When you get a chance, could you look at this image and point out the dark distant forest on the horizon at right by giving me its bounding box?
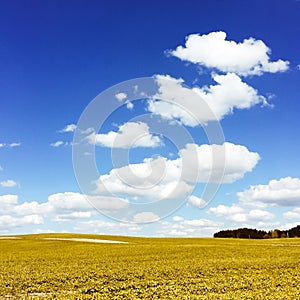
[214,225,300,239]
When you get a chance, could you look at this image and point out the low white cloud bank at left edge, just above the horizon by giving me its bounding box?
[0,192,128,231]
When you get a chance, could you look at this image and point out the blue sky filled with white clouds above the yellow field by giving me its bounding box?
[0,0,300,236]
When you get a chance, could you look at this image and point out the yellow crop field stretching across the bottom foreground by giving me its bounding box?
[0,234,300,300]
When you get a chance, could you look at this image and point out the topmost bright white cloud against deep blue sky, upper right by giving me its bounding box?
[170,31,289,76]
